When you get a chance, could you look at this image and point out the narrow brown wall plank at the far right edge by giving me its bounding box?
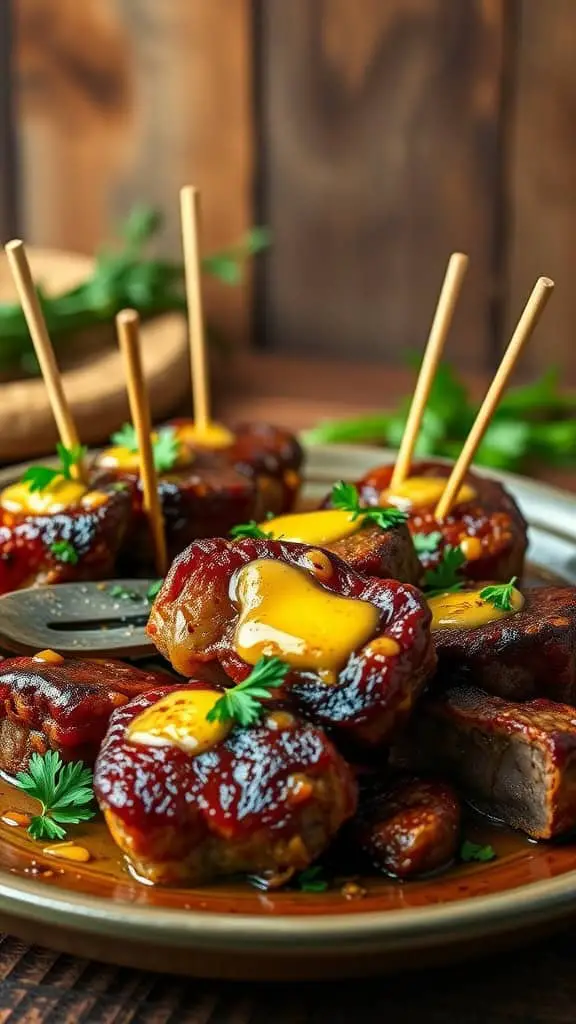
[507,0,576,382]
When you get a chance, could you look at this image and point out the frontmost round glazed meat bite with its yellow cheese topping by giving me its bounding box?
[94,682,356,885]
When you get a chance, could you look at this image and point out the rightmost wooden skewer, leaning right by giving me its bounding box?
[435,278,554,519]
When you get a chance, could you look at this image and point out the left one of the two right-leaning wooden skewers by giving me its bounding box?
[390,253,468,489]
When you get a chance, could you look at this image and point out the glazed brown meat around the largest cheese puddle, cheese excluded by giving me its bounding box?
[148,538,436,748]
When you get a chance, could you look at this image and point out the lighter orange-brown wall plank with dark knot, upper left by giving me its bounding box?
[15,0,252,352]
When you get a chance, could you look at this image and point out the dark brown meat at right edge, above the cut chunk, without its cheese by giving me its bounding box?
[434,587,576,705]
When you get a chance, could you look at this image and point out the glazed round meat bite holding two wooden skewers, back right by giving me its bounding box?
[350,462,528,582]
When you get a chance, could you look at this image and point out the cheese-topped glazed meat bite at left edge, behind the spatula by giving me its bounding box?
[0,477,130,594]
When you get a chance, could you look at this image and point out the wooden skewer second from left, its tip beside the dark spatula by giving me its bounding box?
[116,309,168,577]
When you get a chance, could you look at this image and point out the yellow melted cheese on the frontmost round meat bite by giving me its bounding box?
[126,690,233,757]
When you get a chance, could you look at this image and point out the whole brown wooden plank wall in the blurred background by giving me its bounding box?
[0,0,576,382]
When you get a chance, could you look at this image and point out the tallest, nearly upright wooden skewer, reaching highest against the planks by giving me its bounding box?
[180,185,210,432]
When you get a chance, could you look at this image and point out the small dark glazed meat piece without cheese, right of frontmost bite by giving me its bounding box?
[352,778,460,879]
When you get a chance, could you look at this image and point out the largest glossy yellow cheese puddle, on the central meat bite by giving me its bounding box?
[231,559,379,683]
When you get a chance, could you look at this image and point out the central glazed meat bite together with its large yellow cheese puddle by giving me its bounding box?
[148,539,436,748]
